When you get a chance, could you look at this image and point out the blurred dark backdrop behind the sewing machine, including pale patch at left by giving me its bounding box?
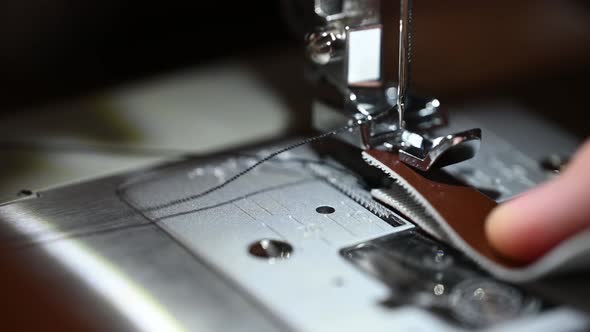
[0,0,590,198]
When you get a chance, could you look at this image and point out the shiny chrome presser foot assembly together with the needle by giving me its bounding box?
[306,0,481,171]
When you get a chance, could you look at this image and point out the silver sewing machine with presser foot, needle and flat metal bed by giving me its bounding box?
[0,0,589,331]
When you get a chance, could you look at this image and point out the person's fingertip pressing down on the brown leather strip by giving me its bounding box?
[486,140,590,261]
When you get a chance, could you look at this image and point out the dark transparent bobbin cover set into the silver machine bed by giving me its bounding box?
[342,230,544,329]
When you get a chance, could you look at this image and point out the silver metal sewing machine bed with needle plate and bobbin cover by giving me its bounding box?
[0,104,590,332]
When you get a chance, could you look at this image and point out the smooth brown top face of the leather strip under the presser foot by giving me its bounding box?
[366,150,523,267]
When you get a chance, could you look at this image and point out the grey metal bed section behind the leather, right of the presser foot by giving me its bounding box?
[442,101,580,201]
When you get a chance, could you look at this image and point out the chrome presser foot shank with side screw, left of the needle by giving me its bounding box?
[306,0,391,150]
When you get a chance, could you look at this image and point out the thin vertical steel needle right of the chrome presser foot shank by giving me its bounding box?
[397,0,412,130]
